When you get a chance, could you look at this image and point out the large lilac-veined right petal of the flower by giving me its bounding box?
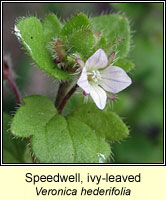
[100,66,132,93]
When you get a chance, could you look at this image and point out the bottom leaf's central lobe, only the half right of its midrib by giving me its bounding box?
[67,117,110,163]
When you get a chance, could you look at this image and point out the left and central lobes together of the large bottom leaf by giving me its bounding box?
[11,95,110,163]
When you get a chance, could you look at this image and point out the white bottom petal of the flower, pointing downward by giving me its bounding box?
[90,85,107,110]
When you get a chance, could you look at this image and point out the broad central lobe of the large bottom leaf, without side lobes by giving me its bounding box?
[31,115,110,163]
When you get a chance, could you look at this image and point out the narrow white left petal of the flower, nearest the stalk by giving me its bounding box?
[77,67,90,94]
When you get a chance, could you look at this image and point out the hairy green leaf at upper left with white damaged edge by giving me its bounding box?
[15,15,69,80]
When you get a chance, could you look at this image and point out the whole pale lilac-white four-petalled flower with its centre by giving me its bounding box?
[77,49,132,110]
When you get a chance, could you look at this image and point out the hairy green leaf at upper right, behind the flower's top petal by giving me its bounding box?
[91,14,130,58]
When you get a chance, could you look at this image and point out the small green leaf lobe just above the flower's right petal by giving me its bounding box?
[113,59,135,72]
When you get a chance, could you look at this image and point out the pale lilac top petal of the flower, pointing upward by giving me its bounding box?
[85,49,108,71]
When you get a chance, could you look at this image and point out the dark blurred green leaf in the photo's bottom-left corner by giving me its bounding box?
[3,113,27,163]
